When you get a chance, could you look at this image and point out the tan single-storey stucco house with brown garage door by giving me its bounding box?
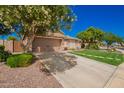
[32,32,81,52]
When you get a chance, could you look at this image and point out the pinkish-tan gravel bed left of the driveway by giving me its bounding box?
[0,61,62,88]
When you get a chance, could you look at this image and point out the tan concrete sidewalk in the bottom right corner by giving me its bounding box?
[105,63,124,88]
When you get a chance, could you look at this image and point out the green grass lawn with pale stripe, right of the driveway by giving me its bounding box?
[72,50,124,66]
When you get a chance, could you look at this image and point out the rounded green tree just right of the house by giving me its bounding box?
[77,27,104,48]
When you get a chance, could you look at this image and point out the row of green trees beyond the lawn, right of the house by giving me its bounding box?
[77,27,124,49]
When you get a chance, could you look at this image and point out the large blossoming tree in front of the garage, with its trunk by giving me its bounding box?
[0,5,75,50]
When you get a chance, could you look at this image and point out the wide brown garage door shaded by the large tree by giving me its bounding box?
[32,38,62,52]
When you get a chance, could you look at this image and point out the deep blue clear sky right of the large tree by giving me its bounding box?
[64,5,124,37]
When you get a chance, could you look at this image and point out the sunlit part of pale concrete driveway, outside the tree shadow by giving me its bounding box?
[35,53,116,88]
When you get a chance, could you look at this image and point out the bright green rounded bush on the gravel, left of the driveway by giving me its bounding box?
[7,54,33,67]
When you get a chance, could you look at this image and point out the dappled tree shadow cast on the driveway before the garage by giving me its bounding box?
[38,52,77,73]
